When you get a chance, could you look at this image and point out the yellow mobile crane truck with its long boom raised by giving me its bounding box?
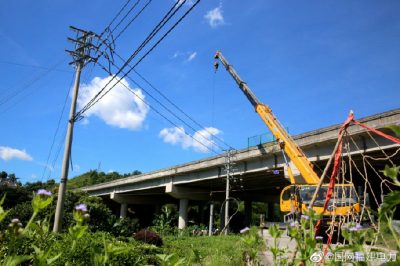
[214,51,360,218]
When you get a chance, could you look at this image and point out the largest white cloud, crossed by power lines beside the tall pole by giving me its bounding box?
[78,76,149,130]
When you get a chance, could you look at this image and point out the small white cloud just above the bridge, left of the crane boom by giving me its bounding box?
[159,127,221,152]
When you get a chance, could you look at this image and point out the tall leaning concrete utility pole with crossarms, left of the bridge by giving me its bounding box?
[53,27,95,232]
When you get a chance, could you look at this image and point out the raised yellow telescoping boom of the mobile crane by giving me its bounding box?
[215,51,319,184]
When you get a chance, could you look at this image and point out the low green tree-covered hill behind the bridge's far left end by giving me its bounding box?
[67,170,142,189]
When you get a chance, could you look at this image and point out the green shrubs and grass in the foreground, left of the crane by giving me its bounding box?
[0,189,262,265]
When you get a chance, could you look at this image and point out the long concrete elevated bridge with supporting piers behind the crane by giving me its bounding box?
[83,109,400,228]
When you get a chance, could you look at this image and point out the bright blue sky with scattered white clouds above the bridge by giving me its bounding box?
[0,0,400,182]
